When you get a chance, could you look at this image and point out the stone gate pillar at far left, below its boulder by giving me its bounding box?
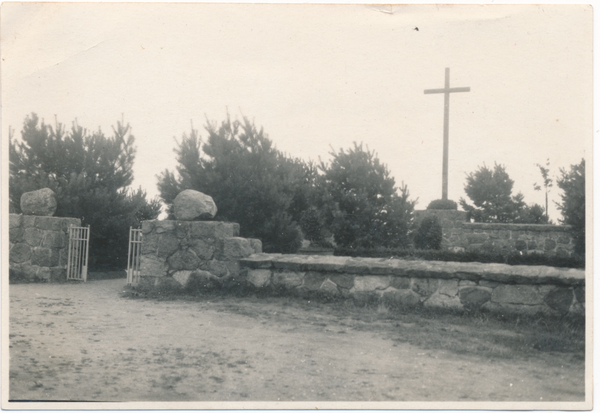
[9,214,81,282]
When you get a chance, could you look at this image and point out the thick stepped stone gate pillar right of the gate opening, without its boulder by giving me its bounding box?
[139,220,262,289]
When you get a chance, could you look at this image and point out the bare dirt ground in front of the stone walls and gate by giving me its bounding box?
[10,280,584,401]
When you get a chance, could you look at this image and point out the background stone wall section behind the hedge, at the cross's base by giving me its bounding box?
[415,210,575,256]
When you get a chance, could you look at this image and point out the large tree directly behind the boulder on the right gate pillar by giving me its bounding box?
[158,116,314,252]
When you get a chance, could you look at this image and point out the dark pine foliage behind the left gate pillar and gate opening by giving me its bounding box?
[9,114,160,267]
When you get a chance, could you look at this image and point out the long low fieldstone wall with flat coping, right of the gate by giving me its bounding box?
[240,254,585,316]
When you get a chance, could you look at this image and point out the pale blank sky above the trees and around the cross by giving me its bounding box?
[1,3,593,222]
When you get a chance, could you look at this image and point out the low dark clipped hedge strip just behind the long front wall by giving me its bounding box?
[334,247,585,268]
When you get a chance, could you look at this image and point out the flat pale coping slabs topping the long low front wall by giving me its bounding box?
[240,253,585,286]
